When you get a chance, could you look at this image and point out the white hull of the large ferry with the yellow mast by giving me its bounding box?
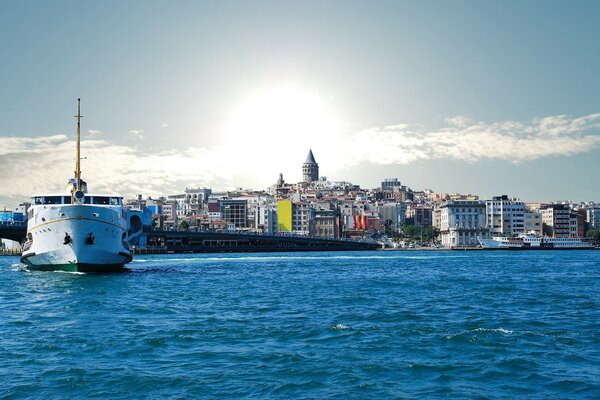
[21,205,132,272]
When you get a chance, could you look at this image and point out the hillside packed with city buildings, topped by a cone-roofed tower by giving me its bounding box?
[116,150,600,247]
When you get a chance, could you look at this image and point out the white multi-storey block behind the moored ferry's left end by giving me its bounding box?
[485,195,525,236]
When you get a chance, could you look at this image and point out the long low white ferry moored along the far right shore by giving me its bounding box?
[478,233,594,250]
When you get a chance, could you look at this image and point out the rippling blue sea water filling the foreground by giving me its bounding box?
[0,251,600,399]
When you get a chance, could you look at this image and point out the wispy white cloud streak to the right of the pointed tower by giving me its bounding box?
[340,114,600,167]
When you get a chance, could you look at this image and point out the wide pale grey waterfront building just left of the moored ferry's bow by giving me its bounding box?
[438,200,489,247]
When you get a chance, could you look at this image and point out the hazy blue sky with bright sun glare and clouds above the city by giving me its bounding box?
[0,0,600,207]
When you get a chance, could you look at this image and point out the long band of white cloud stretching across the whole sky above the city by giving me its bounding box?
[0,114,600,206]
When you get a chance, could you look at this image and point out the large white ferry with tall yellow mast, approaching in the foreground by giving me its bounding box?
[21,99,132,272]
